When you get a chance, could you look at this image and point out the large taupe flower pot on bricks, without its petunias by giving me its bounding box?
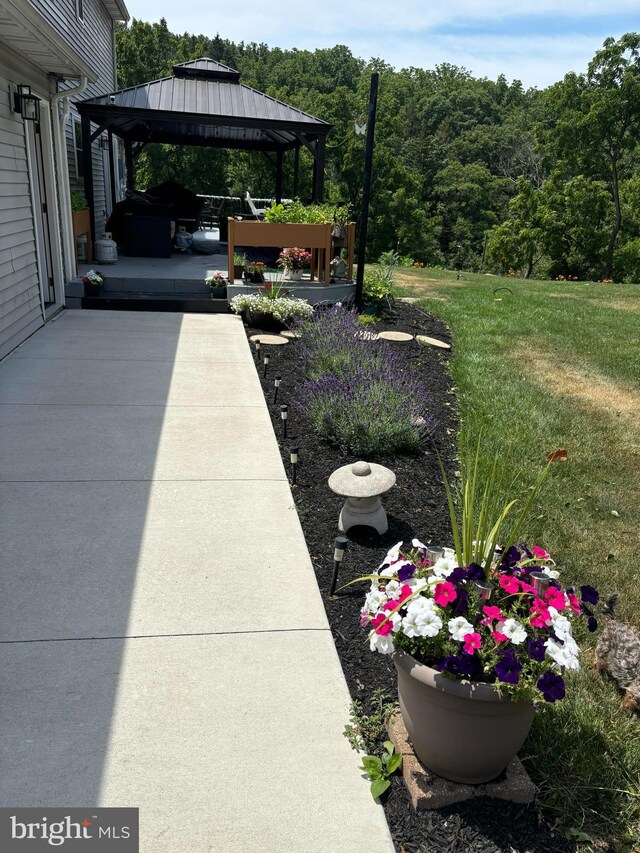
[393,649,534,785]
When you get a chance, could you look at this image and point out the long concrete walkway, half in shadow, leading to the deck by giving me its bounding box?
[0,311,393,853]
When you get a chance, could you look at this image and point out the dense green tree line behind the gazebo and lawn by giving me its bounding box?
[116,19,640,281]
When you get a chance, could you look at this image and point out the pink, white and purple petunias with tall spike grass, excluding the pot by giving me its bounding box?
[360,442,598,702]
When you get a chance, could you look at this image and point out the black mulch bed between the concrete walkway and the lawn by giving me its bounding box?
[246,302,575,853]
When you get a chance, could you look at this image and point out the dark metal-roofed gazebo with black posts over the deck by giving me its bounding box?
[77,57,332,239]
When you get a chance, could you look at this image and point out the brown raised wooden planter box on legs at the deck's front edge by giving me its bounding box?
[227,217,355,285]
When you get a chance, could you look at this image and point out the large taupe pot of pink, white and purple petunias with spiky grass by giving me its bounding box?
[361,446,598,784]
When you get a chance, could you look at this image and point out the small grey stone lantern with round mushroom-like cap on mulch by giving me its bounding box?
[329,462,396,534]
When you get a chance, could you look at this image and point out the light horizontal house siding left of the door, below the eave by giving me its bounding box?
[0,65,43,358]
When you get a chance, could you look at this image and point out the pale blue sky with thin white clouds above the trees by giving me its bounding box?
[125,0,640,88]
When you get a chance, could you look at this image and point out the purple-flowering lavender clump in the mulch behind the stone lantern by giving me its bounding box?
[295,308,433,456]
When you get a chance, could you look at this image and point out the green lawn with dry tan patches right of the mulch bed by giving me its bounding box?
[398,269,640,851]
